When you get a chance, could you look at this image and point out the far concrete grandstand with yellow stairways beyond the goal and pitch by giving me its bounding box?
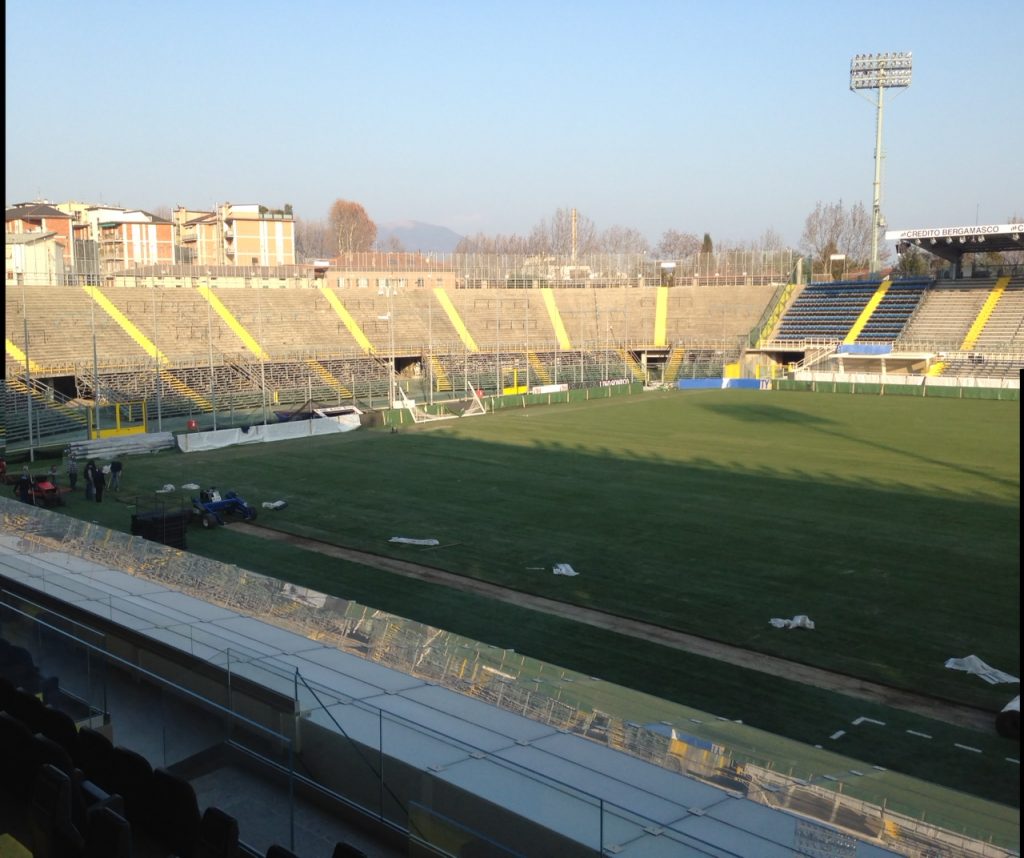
[3,231,1024,448]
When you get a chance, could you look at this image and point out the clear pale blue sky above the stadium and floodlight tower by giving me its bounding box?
[5,0,1024,245]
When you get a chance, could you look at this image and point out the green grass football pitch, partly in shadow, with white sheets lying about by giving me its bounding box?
[71,390,1020,806]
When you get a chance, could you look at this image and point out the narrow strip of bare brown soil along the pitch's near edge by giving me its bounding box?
[231,522,995,733]
